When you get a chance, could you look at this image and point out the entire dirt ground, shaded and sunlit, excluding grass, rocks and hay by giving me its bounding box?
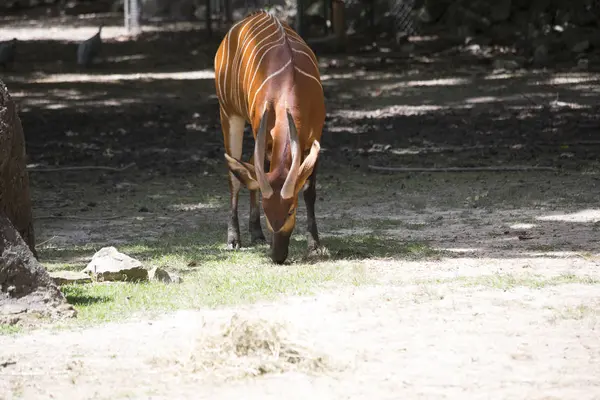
[0,10,600,399]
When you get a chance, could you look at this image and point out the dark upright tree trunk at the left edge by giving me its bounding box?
[0,81,37,258]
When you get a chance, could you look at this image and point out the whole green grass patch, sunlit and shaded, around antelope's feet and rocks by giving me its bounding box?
[41,224,439,323]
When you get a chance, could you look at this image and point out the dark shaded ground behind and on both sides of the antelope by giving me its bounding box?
[3,14,600,269]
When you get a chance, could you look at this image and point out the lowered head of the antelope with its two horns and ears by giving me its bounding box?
[225,108,321,264]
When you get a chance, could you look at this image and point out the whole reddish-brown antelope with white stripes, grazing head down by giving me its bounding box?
[215,11,325,263]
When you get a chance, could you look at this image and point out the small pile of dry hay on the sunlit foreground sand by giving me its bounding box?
[191,314,329,379]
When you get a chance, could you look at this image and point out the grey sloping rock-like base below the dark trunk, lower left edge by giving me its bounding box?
[0,214,76,325]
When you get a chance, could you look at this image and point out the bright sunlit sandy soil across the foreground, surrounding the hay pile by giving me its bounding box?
[0,259,600,399]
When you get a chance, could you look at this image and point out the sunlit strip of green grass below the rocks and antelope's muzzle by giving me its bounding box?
[62,263,364,323]
